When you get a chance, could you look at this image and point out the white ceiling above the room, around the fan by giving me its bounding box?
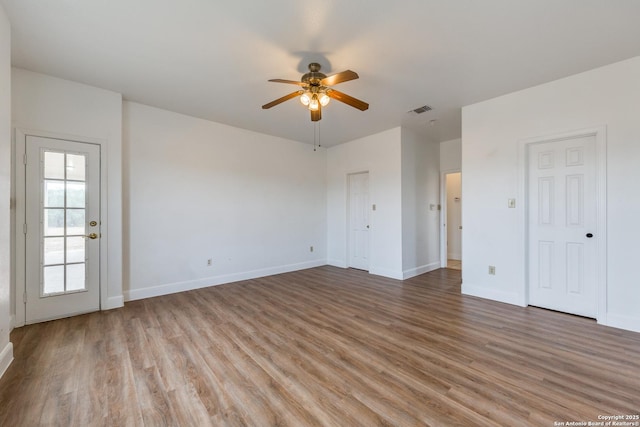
[0,0,640,146]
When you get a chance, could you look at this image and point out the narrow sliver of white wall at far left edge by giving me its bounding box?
[0,5,13,376]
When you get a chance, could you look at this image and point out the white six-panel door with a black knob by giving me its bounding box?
[528,136,601,317]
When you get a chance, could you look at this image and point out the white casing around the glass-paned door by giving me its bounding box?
[13,128,109,327]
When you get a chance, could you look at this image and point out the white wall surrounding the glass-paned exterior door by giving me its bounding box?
[12,68,123,318]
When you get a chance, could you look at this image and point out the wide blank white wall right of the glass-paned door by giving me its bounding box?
[123,102,326,299]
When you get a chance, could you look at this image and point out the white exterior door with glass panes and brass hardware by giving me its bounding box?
[24,136,100,324]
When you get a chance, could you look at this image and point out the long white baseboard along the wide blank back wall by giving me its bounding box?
[124,259,327,301]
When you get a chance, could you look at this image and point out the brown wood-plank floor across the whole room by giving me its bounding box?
[0,267,640,426]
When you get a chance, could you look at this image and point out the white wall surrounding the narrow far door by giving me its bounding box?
[327,127,403,279]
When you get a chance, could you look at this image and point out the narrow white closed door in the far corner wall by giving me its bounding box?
[348,172,370,271]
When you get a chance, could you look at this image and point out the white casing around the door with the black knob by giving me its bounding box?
[518,125,607,324]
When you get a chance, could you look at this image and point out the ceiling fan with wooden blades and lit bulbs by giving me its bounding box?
[262,62,369,122]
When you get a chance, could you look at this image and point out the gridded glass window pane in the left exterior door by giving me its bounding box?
[41,150,87,297]
